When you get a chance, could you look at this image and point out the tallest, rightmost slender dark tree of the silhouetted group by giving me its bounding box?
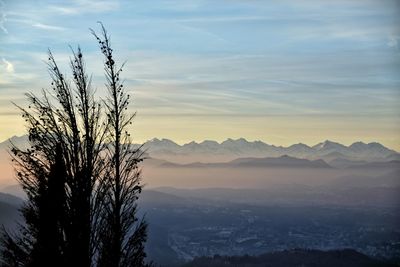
[92,25,147,267]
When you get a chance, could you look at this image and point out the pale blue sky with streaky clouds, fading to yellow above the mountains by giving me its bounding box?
[0,0,400,151]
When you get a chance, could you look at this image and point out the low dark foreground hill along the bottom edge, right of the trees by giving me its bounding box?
[184,249,396,267]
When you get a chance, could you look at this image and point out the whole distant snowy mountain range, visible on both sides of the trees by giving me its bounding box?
[0,136,400,166]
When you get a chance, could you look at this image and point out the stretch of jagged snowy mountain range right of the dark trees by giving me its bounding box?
[145,138,399,161]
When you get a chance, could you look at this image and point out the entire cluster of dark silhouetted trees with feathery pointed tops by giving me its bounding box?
[2,25,147,266]
